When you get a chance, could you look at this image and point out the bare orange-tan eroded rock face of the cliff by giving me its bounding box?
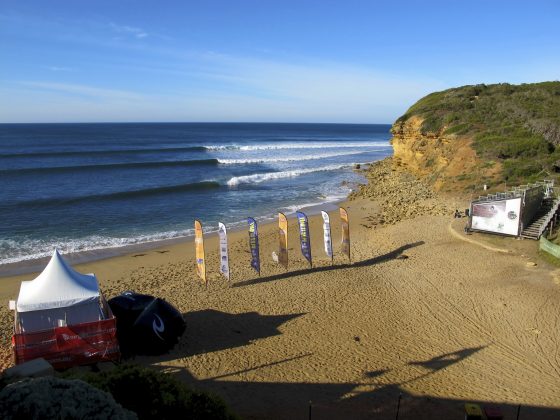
[391,116,501,191]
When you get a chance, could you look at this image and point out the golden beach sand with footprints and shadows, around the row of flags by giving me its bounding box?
[0,159,560,419]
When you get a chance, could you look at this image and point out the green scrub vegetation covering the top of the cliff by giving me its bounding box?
[395,82,560,183]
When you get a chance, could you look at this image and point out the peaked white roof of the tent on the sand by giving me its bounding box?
[16,250,100,312]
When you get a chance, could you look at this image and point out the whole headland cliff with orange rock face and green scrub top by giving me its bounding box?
[391,82,560,191]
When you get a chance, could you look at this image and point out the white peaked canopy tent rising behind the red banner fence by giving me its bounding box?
[16,250,105,332]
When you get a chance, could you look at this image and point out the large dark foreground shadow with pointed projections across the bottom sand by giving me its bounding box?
[158,346,560,420]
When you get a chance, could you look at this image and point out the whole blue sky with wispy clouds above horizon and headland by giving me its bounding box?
[0,0,560,123]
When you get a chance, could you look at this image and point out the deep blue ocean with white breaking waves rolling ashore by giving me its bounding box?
[0,123,392,264]
